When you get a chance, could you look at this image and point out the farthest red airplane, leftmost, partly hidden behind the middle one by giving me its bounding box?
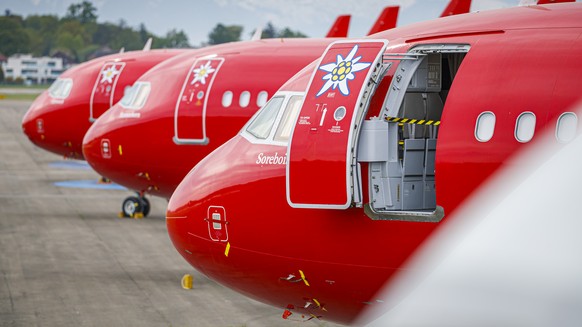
[22,50,184,159]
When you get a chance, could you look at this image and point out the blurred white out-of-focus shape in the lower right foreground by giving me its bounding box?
[362,102,582,327]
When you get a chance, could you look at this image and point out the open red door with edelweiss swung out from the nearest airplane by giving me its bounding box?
[286,40,388,209]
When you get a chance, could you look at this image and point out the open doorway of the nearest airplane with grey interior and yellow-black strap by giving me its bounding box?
[358,43,470,222]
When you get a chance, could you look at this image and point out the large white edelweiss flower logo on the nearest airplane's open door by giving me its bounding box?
[315,44,372,97]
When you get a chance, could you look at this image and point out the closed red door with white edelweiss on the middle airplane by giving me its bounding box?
[174,57,224,144]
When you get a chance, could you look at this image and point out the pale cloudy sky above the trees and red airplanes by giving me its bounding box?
[0,0,576,47]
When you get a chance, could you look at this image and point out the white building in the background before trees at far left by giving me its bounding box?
[2,54,65,84]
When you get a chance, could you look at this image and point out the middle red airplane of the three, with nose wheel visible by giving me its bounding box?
[83,1,474,217]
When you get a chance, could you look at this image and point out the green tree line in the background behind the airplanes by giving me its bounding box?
[0,1,305,62]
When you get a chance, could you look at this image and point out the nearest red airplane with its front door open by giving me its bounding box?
[166,4,582,324]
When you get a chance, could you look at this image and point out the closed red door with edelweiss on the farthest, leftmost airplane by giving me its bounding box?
[89,61,125,122]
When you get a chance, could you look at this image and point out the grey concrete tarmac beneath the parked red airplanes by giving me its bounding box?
[0,100,333,327]
